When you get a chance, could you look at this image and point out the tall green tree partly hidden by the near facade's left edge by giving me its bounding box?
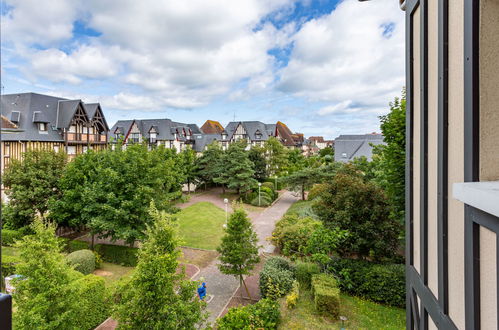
[373,90,406,223]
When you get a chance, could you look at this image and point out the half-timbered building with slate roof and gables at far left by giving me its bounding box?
[1,93,108,172]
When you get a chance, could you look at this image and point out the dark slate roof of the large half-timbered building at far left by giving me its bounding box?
[0,93,106,142]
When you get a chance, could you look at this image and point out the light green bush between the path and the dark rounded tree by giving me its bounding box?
[272,215,322,256]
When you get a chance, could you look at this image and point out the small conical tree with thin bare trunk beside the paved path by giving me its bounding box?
[217,209,260,298]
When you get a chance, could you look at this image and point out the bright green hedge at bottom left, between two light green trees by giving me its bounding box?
[71,274,109,329]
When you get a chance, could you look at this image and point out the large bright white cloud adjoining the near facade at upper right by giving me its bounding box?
[279,0,405,107]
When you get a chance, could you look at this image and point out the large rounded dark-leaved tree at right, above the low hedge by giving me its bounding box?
[313,171,401,260]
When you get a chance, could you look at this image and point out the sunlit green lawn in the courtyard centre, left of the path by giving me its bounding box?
[175,202,225,250]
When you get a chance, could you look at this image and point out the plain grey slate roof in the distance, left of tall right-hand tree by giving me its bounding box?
[334,134,384,162]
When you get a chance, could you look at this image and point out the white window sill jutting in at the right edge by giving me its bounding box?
[452,181,499,217]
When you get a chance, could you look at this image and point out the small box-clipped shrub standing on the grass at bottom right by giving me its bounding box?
[312,274,340,318]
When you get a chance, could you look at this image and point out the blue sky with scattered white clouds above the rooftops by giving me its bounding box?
[0,0,405,138]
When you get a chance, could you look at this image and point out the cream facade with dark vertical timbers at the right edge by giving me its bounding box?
[401,0,499,329]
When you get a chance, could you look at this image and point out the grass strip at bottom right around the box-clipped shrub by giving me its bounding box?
[279,290,405,330]
